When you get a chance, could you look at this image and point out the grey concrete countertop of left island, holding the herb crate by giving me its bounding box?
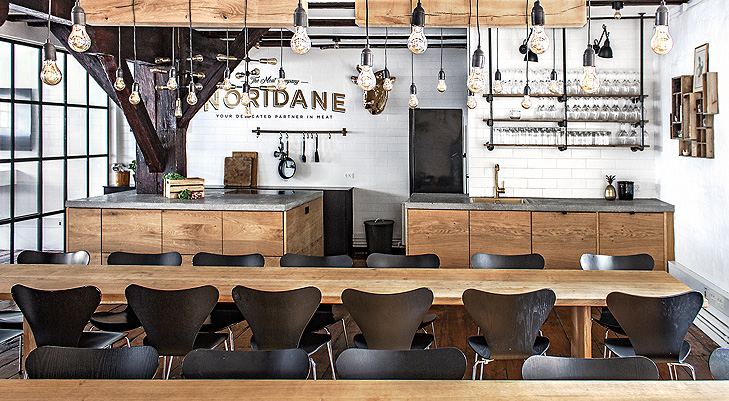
[66,188,323,212]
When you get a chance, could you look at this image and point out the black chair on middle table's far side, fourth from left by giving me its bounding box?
[279,253,352,347]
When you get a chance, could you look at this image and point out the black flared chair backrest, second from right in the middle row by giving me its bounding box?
[462,288,557,359]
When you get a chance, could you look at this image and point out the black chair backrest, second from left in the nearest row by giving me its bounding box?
[181,348,309,380]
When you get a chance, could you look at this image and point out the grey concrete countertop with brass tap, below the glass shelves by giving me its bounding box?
[403,194,674,213]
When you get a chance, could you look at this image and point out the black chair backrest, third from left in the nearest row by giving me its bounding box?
[336,344,466,380]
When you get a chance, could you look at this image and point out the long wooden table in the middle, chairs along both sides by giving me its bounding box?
[0,265,691,357]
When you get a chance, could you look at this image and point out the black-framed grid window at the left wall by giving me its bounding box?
[0,38,110,263]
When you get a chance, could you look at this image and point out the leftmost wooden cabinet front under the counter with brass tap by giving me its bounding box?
[407,209,471,268]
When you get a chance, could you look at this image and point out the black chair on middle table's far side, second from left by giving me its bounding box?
[91,252,182,331]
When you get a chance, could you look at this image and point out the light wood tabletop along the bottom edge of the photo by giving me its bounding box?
[0,380,729,401]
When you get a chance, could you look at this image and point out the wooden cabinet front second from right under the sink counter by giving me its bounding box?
[532,212,597,269]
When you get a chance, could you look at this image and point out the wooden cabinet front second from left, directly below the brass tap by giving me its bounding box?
[470,210,532,255]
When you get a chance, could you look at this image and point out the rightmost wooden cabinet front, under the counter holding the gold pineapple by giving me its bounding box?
[598,213,673,270]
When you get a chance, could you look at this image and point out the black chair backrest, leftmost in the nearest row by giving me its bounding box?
[25,347,159,380]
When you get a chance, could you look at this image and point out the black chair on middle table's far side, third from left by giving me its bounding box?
[192,252,265,351]
